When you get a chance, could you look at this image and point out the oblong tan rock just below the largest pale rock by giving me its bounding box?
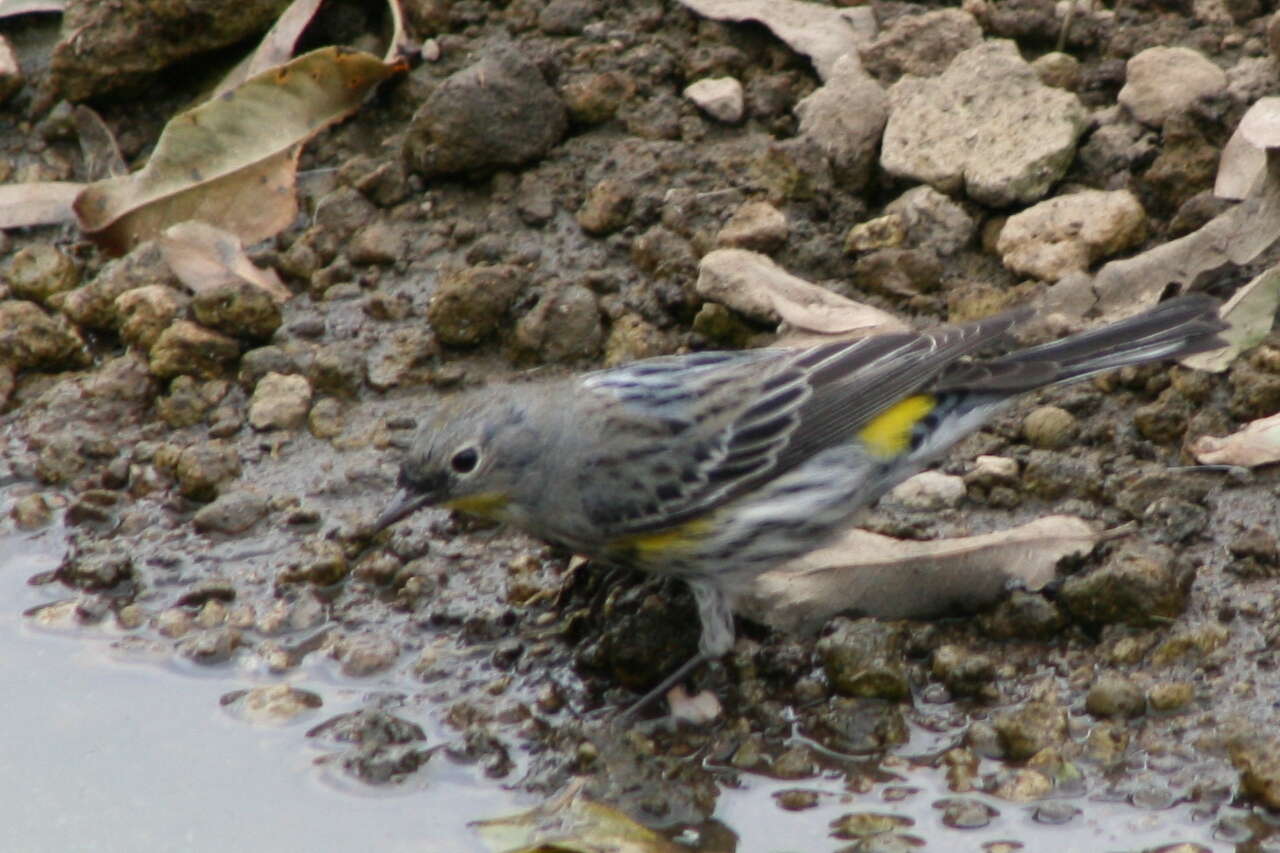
[996,190,1147,282]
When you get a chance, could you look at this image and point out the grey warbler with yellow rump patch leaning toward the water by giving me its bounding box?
[374,295,1224,713]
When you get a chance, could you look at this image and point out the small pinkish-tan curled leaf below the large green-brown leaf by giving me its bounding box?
[156,220,293,305]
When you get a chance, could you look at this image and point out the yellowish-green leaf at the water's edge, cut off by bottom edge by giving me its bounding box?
[470,780,686,853]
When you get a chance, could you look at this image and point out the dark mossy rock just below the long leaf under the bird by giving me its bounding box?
[815,617,910,702]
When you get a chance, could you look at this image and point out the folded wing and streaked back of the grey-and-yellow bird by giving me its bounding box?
[582,308,1019,535]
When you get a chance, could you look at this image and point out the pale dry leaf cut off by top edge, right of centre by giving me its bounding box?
[680,0,877,79]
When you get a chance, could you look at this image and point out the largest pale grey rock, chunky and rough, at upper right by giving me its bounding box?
[881,41,1088,207]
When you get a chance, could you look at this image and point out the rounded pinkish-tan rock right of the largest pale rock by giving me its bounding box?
[1117,47,1226,127]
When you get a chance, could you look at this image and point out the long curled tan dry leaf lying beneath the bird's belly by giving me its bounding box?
[739,515,1105,631]
